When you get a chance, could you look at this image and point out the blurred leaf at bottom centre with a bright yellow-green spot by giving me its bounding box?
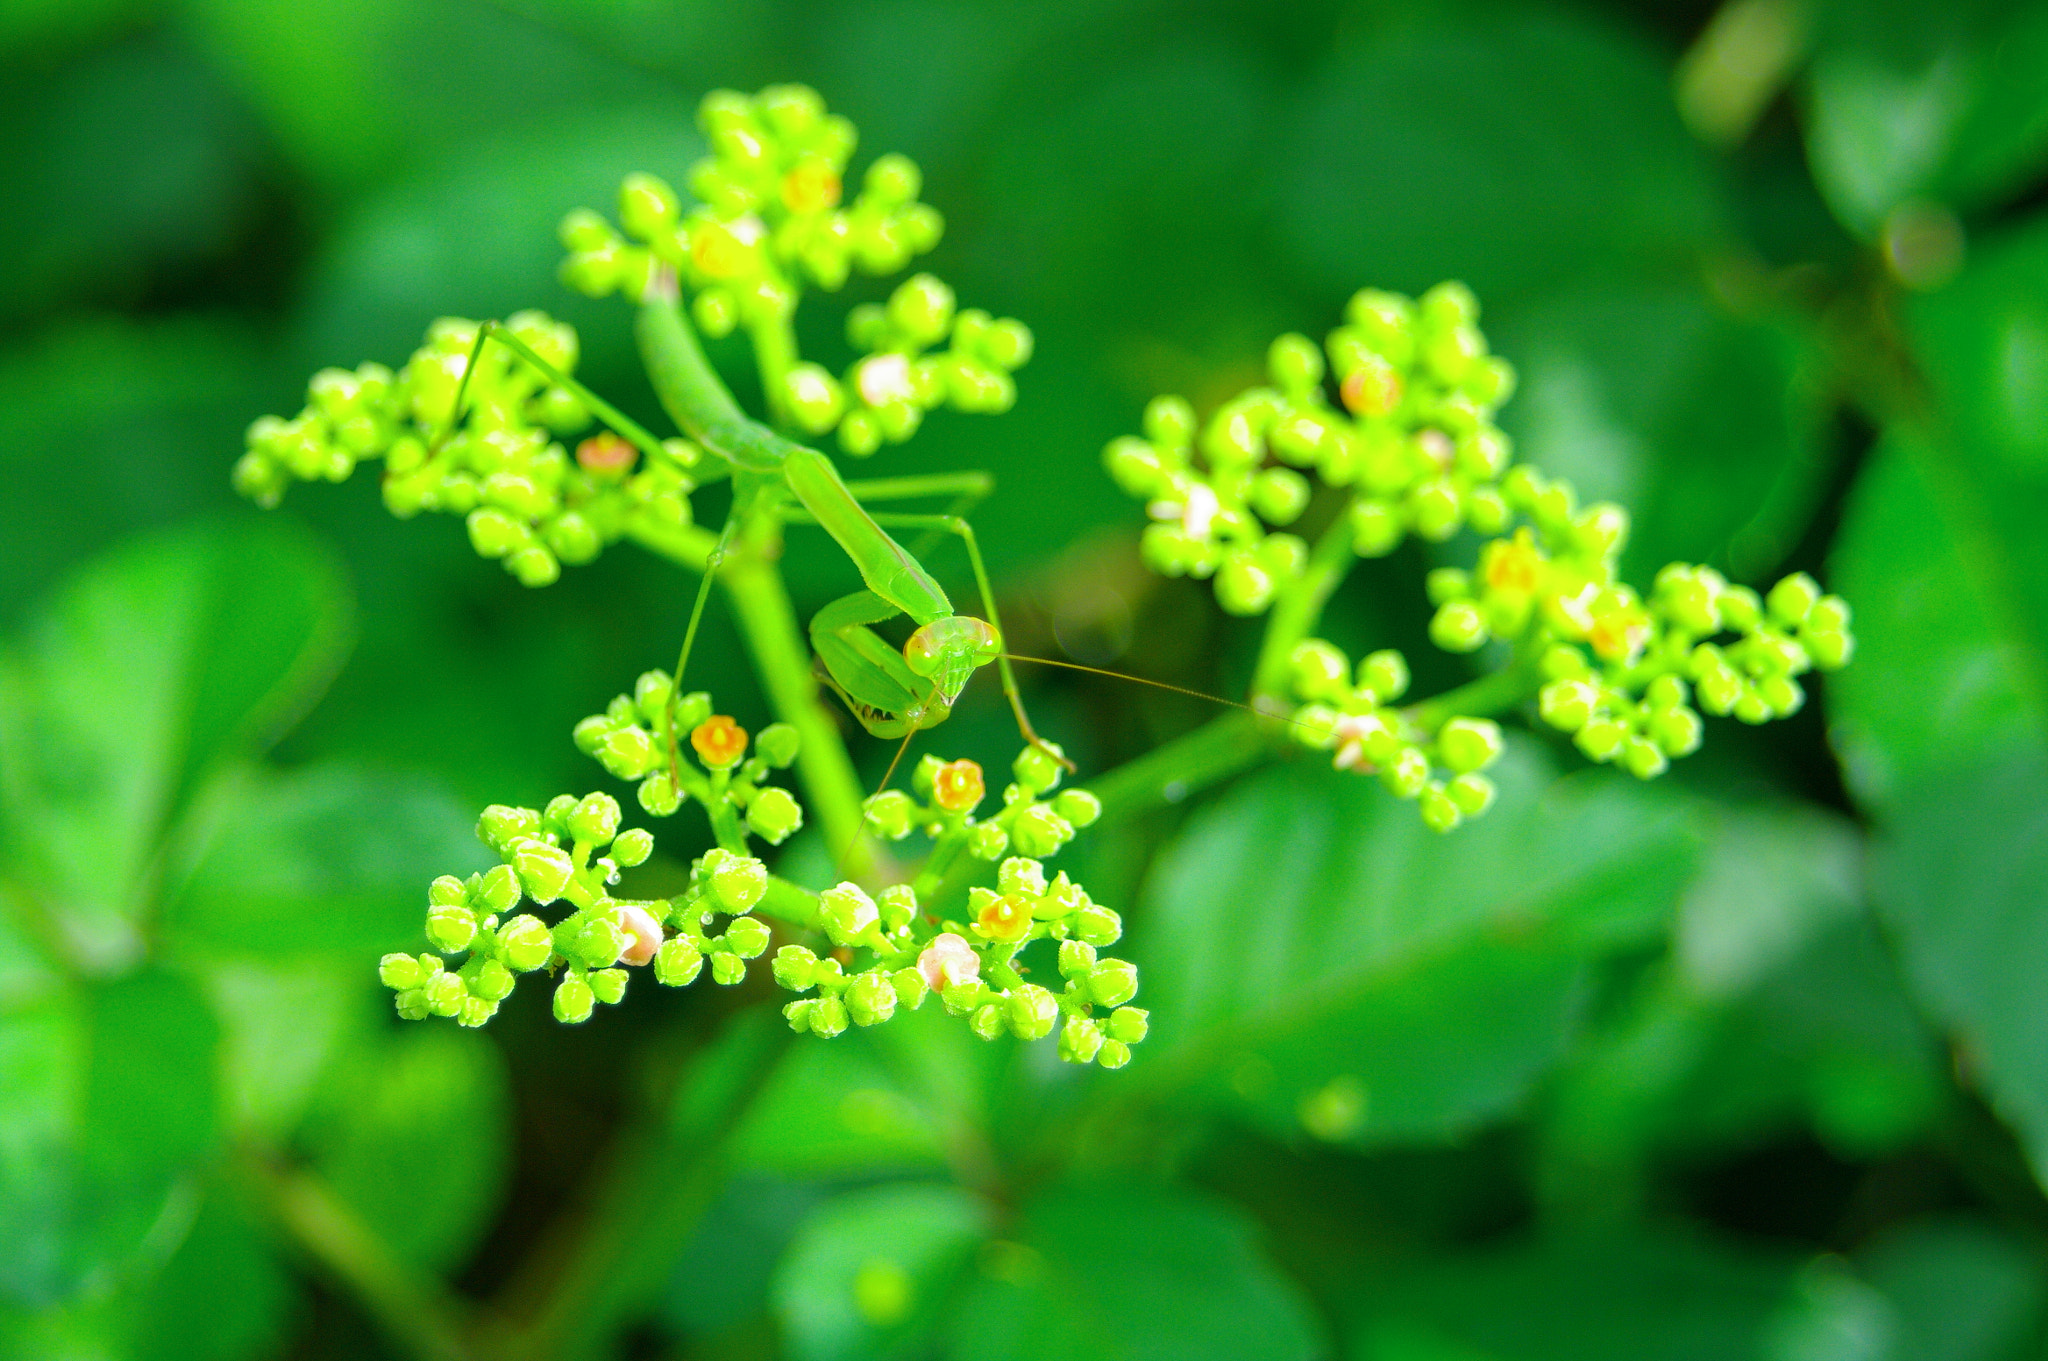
[774,1185,989,1361]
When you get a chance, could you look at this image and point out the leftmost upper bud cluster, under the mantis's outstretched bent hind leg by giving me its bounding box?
[233,311,698,585]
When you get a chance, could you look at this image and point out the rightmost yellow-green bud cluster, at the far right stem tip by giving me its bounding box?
[1538,563,1855,780]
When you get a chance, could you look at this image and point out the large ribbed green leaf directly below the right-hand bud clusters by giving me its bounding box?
[1128,747,1696,1142]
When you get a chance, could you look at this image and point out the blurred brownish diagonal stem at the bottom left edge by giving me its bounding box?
[242,1152,477,1361]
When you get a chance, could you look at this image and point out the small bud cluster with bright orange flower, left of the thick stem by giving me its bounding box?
[571,671,803,845]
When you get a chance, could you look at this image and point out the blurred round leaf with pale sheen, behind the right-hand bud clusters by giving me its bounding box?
[1493,284,1825,587]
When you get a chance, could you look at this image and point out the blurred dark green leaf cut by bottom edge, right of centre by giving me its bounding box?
[1346,1234,1790,1361]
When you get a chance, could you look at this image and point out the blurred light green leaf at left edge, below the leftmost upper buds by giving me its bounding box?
[0,522,348,966]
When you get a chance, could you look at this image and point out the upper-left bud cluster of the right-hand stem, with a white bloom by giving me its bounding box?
[1104,282,1513,614]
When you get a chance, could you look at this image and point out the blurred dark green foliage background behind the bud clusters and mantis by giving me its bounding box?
[0,0,2048,1361]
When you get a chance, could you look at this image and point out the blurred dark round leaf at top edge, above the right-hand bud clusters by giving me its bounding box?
[1280,6,1720,307]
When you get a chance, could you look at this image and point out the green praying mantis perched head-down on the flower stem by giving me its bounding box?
[451,272,1073,770]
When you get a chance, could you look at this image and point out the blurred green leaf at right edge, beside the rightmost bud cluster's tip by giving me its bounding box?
[1829,430,2048,810]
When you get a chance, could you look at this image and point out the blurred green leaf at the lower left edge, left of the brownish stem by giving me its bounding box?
[0,972,217,1304]
